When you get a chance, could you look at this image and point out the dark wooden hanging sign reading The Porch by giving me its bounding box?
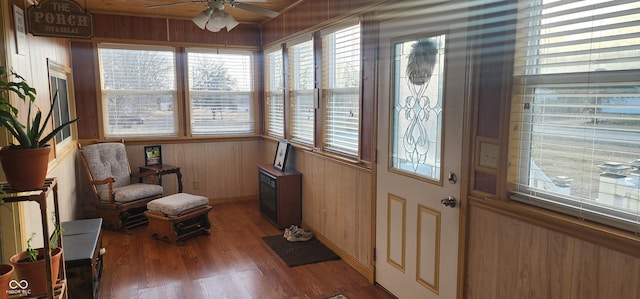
[27,0,93,38]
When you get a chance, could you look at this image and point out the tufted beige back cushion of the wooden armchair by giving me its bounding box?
[80,142,131,190]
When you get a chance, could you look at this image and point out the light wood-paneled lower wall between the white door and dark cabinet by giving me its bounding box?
[263,140,375,281]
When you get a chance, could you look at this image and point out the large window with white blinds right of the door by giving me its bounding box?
[509,0,640,233]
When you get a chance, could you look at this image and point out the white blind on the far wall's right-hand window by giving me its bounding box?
[187,50,255,135]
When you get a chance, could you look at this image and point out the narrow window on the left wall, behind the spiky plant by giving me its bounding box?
[48,61,72,145]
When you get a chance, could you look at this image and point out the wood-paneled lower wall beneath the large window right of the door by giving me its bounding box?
[465,201,640,299]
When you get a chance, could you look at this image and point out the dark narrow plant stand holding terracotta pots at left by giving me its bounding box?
[0,178,67,299]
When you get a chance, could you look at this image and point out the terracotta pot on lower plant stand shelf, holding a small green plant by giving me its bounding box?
[9,248,62,296]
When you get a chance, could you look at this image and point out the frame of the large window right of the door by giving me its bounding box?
[508,3,640,233]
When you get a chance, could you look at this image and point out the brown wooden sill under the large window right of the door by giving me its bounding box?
[469,196,640,258]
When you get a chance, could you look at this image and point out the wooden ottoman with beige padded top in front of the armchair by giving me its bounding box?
[145,193,211,245]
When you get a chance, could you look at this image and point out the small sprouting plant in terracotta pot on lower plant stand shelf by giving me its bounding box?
[9,217,63,296]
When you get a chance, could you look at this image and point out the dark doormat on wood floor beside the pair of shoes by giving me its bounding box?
[262,235,340,267]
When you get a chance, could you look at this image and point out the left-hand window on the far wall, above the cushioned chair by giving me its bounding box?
[98,44,177,137]
